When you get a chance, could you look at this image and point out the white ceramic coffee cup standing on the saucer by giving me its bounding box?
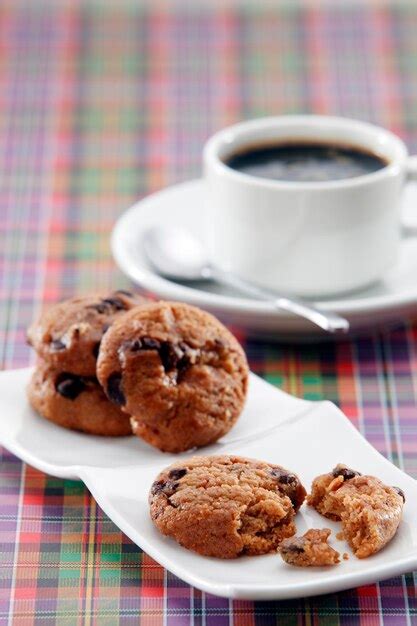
[203,115,417,297]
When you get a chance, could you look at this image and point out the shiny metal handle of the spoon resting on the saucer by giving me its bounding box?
[210,265,349,333]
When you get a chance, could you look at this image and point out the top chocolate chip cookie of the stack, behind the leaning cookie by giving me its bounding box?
[28,290,148,376]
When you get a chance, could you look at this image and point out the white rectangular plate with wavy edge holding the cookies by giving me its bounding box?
[0,369,417,600]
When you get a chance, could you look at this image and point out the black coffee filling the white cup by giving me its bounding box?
[225,142,387,182]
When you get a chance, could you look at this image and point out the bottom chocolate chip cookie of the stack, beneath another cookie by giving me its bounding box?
[27,363,132,437]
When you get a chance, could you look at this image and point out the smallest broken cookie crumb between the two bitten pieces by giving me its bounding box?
[279,528,340,567]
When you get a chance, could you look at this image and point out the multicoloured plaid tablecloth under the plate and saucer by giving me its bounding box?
[0,0,417,626]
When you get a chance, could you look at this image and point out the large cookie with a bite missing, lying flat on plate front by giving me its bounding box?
[149,456,306,559]
